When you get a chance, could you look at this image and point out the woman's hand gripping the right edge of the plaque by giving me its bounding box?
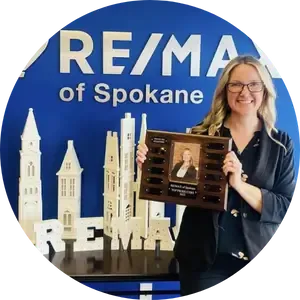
[223,151,243,190]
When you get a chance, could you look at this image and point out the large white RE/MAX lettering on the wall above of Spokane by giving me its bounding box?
[59,30,281,78]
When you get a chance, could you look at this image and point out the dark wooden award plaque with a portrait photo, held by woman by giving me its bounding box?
[139,130,232,211]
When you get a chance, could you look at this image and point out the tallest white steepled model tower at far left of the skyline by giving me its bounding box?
[18,108,43,245]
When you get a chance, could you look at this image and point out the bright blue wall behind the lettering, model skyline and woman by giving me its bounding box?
[0,0,300,296]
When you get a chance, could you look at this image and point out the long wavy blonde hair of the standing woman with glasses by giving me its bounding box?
[191,55,286,151]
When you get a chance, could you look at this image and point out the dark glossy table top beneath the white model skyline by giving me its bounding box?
[43,246,178,282]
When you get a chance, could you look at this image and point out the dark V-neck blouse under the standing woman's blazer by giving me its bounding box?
[218,127,260,259]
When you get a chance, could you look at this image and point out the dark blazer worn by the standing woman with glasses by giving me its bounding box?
[174,120,297,271]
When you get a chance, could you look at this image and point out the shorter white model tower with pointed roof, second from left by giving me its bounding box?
[56,140,83,239]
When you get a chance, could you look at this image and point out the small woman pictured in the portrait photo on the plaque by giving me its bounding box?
[171,148,197,182]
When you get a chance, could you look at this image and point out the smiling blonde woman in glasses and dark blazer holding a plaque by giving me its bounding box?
[136,56,296,296]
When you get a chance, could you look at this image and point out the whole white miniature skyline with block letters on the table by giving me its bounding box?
[18,108,188,255]
